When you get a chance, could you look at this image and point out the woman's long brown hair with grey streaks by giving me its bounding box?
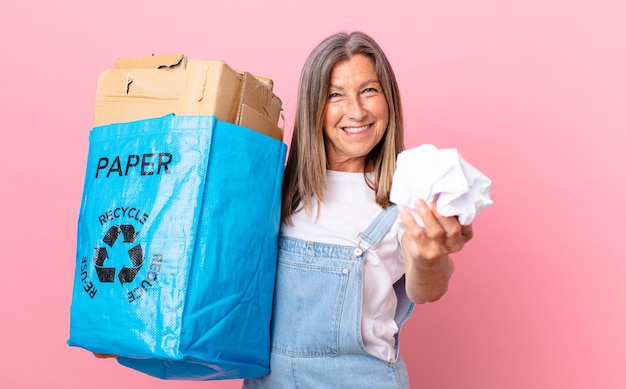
[281,32,404,223]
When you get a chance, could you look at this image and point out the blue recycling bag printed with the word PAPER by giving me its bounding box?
[68,115,286,380]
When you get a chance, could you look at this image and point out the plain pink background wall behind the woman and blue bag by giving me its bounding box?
[0,0,626,389]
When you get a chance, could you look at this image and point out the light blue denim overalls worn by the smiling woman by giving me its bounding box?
[243,205,413,389]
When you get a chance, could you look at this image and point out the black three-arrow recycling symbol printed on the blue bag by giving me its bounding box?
[93,224,143,284]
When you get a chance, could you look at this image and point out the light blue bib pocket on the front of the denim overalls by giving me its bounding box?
[272,259,350,357]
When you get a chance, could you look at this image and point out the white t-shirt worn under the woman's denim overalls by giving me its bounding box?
[281,170,404,361]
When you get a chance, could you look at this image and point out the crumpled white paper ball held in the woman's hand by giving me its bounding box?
[390,144,493,227]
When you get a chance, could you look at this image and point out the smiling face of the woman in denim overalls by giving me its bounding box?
[324,54,389,172]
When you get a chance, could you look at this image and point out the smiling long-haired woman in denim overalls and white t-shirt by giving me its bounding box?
[244,32,472,389]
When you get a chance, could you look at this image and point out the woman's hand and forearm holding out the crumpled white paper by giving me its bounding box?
[399,200,473,303]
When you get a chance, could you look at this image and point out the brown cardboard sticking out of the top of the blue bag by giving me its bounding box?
[95,54,283,141]
